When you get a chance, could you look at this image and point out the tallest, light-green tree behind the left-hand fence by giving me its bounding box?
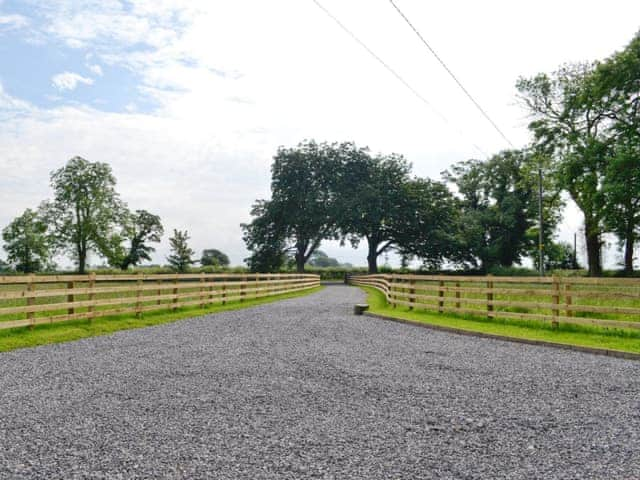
[43,157,126,274]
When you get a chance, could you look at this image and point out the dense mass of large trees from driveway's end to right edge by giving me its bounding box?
[242,34,640,276]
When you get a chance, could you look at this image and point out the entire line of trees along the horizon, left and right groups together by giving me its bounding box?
[0,35,640,276]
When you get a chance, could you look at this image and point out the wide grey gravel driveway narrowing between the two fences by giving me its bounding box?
[0,286,640,480]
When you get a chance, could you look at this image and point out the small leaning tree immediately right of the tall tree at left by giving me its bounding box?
[111,210,164,270]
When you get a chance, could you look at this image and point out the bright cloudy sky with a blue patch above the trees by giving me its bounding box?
[0,0,640,265]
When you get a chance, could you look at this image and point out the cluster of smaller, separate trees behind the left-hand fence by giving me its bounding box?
[0,157,229,274]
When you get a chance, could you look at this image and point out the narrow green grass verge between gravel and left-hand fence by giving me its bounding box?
[0,287,323,352]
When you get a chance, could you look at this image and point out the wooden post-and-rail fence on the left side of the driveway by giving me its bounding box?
[0,273,320,330]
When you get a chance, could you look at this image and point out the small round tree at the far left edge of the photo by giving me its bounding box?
[2,208,50,273]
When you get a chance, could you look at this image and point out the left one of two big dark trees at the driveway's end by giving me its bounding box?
[242,141,336,272]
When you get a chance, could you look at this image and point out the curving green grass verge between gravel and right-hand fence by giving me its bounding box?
[360,287,640,353]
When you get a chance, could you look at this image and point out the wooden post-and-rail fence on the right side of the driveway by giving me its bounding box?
[348,275,640,329]
